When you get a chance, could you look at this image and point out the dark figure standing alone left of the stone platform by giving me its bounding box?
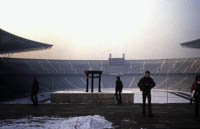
[31,77,39,106]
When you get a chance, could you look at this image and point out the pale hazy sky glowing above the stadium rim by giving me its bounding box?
[0,0,200,59]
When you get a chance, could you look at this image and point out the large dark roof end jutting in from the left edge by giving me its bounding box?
[0,29,53,54]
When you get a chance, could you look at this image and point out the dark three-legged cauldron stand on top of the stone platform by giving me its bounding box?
[85,70,103,93]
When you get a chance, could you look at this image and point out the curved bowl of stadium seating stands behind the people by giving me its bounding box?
[1,55,200,103]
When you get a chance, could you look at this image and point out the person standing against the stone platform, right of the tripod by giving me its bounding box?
[115,76,123,104]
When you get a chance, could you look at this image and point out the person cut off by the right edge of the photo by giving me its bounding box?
[194,75,200,117]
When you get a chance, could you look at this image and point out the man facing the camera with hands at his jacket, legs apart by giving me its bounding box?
[138,71,156,117]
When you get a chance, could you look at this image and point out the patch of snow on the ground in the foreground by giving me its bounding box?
[0,115,113,129]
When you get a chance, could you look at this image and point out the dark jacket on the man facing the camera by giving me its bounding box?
[138,77,156,92]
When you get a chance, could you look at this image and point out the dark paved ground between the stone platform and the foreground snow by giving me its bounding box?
[0,104,200,129]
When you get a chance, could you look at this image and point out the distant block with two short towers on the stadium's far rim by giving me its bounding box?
[108,53,125,65]
